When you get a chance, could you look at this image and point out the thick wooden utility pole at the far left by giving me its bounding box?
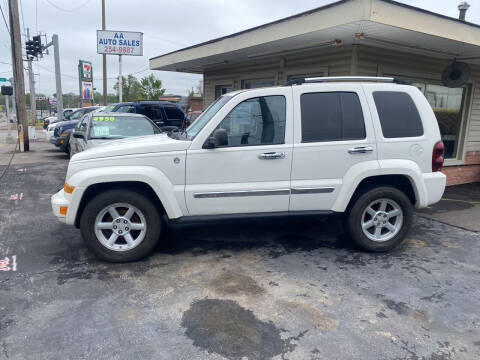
[8,0,30,151]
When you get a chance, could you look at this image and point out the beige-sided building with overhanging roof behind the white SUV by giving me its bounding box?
[150,0,480,185]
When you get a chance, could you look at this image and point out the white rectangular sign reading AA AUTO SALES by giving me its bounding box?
[97,30,143,56]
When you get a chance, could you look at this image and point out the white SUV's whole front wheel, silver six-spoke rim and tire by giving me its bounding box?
[80,189,162,262]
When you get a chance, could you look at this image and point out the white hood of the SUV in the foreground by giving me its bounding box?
[70,134,190,161]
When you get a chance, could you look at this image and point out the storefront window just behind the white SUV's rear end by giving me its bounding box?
[414,83,467,159]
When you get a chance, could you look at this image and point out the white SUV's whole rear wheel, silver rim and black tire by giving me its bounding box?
[346,186,413,252]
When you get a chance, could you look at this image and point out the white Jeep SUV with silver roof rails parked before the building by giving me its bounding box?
[51,77,446,262]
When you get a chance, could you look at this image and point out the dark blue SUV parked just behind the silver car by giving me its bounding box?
[109,100,185,131]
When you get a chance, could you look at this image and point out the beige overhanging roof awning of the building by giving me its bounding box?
[150,0,480,73]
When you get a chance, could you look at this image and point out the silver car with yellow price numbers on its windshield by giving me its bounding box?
[70,112,161,157]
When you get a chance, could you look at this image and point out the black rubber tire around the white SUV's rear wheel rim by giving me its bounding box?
[345,186,413,252]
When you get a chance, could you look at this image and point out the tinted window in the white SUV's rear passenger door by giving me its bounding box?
[300,92,366,142]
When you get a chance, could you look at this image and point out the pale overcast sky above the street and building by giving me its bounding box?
[0,0,480,95]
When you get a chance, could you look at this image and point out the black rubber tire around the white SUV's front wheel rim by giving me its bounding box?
[80,188,163,262]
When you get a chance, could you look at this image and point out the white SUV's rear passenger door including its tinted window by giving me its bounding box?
[290,83,378,211]
